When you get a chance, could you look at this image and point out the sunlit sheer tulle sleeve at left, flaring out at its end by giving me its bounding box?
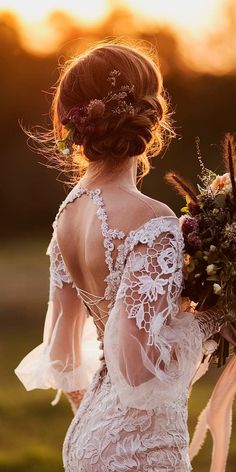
[15,235,99,398]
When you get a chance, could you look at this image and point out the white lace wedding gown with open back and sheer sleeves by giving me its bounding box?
[15,183,219,472]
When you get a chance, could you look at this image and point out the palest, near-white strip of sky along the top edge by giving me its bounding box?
[0,0,224,33]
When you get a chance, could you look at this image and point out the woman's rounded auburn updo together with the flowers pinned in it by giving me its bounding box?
[50,42,175,181]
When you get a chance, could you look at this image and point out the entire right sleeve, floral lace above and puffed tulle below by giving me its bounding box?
[104,217,207,409]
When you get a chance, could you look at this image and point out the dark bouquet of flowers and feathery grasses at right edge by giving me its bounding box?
[166,134,236,366]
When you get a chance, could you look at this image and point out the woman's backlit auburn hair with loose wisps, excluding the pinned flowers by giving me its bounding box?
[27,41,175,183]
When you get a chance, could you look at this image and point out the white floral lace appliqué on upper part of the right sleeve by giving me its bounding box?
[117,219,183,347]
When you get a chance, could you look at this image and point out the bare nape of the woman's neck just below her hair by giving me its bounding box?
[80,157,137,189]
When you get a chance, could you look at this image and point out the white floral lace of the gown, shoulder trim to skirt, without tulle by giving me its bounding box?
[44,187,221,472]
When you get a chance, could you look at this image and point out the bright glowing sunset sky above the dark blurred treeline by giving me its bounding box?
[0,0,236,73]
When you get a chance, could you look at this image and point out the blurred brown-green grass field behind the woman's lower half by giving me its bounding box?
[0,240,236,472]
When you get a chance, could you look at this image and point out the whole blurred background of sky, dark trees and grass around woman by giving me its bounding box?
[0,0,236,472]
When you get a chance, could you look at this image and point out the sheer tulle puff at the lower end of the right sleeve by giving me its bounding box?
[105,306,202,410]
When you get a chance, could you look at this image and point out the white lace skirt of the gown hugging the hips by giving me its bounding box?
[63,375,191,472]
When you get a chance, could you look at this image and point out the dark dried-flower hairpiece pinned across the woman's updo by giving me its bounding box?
[56,69,134,156]
